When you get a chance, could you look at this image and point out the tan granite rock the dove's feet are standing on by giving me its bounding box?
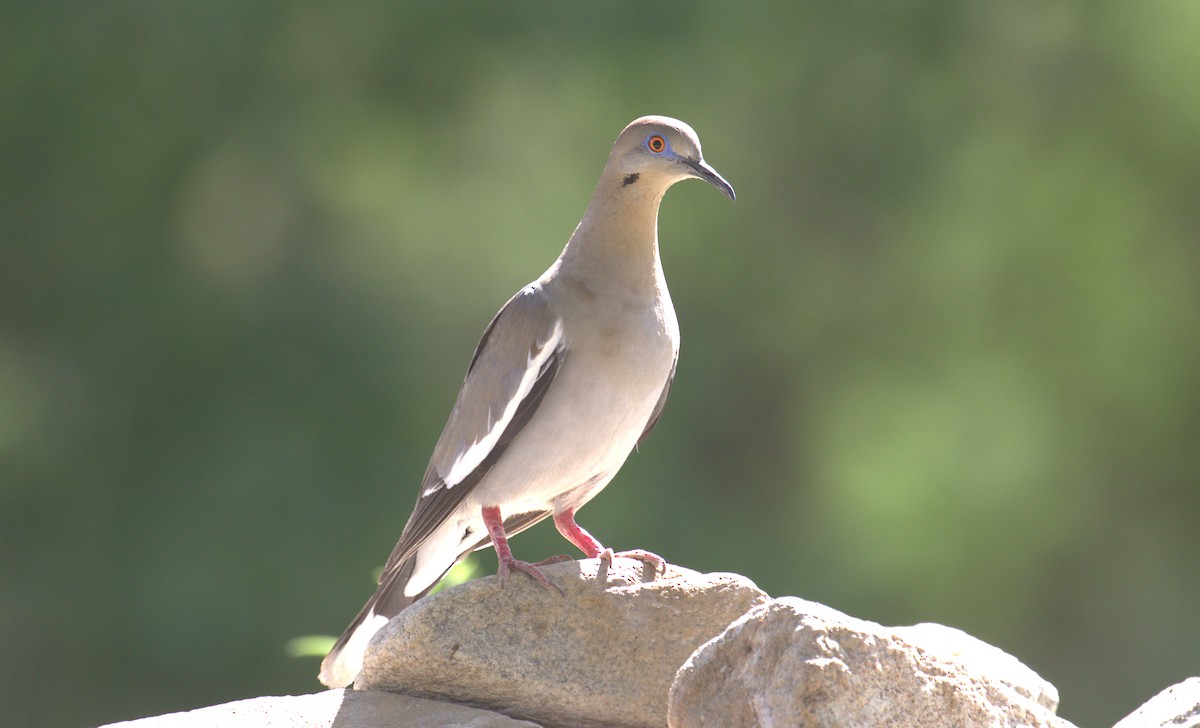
[355,559,768,728]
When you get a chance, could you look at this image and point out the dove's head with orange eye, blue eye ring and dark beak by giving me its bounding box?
[608,116,736,200]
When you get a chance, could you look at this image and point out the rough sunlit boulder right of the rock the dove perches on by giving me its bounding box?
[668,597,1070,728]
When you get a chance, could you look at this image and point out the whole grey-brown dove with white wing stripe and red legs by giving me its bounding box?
[320,116,734,687]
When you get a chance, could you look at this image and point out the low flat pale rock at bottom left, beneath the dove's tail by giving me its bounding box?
[101,690,538,728]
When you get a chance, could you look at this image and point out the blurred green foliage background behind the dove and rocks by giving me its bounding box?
[0,0,1200,727]
